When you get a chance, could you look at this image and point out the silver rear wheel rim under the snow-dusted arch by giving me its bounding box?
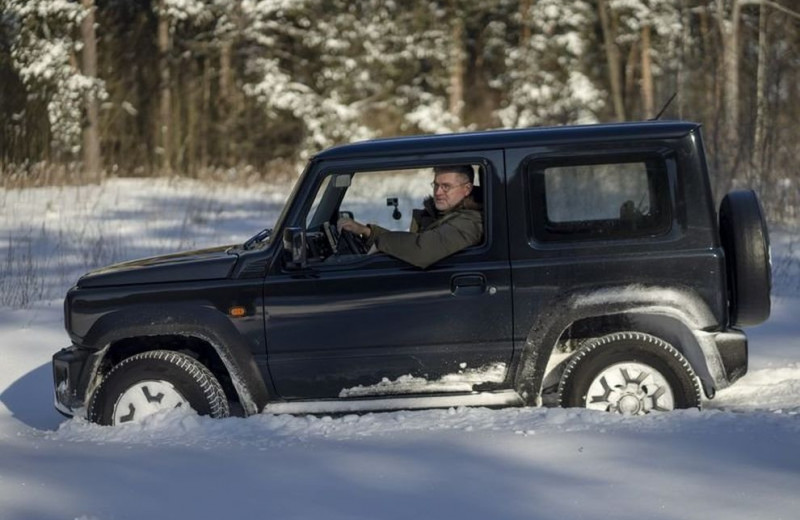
[586,363,675,415]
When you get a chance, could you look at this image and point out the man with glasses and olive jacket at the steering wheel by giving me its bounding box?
[337,165,483,269]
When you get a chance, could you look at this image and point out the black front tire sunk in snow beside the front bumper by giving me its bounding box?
[88,350,230,425]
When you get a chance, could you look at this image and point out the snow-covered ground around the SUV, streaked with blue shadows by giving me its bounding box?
[0,180,800,520]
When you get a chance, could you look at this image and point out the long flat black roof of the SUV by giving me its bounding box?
[314,121,700,159]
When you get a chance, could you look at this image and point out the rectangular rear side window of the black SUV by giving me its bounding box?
[528,156,671,241]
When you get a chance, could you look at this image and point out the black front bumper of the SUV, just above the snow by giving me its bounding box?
[53,346,102,417]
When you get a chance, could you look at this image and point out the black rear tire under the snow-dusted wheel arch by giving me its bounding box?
[558,332,700,415]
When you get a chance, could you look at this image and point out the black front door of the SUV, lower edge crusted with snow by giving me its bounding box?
[264,151,513,399]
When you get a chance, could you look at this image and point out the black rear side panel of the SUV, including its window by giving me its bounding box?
[506,138,688,344]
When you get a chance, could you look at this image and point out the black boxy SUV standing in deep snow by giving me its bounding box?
[53,121,771,424]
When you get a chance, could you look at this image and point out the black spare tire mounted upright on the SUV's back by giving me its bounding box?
[719,190,772,326]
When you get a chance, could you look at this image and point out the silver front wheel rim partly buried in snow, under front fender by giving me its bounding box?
[114,381,189,424]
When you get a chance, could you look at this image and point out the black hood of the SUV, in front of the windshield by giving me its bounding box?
[78,246,238,287]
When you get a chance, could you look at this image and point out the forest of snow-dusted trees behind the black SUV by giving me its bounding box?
[0,0,800,222]
